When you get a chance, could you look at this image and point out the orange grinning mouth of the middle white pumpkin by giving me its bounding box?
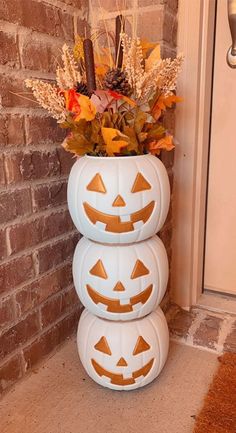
[86,284,153,313]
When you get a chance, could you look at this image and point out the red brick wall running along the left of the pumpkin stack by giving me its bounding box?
[0,0,87,392]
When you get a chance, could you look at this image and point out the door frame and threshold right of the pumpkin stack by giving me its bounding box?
[171,0,236,312]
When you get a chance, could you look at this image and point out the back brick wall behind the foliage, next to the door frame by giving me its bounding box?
[89,0,178,308]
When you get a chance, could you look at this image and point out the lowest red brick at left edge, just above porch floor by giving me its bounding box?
[0,355,22,393]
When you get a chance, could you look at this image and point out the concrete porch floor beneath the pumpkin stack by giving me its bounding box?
[0,339,217,433]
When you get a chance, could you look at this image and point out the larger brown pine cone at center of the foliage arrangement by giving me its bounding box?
[104,68,132,96]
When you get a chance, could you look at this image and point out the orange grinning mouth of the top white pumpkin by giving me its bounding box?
[83,201,155,233]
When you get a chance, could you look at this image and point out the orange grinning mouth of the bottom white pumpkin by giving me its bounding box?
[91,358,154,386]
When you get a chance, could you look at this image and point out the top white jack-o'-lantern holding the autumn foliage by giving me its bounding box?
[68,155,170,243]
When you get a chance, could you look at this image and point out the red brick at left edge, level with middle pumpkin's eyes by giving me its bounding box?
[0,255,34,294]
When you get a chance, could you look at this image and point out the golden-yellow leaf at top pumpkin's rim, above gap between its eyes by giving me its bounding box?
[101,127,129,156]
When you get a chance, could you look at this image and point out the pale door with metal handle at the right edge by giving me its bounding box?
[204,0,236,295]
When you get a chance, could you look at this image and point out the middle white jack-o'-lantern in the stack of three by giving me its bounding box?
[73,236,168,320]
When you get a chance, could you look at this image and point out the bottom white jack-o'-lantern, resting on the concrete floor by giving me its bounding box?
[77,307,169,391]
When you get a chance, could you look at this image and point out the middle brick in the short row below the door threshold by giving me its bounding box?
[193,315,223,349]
